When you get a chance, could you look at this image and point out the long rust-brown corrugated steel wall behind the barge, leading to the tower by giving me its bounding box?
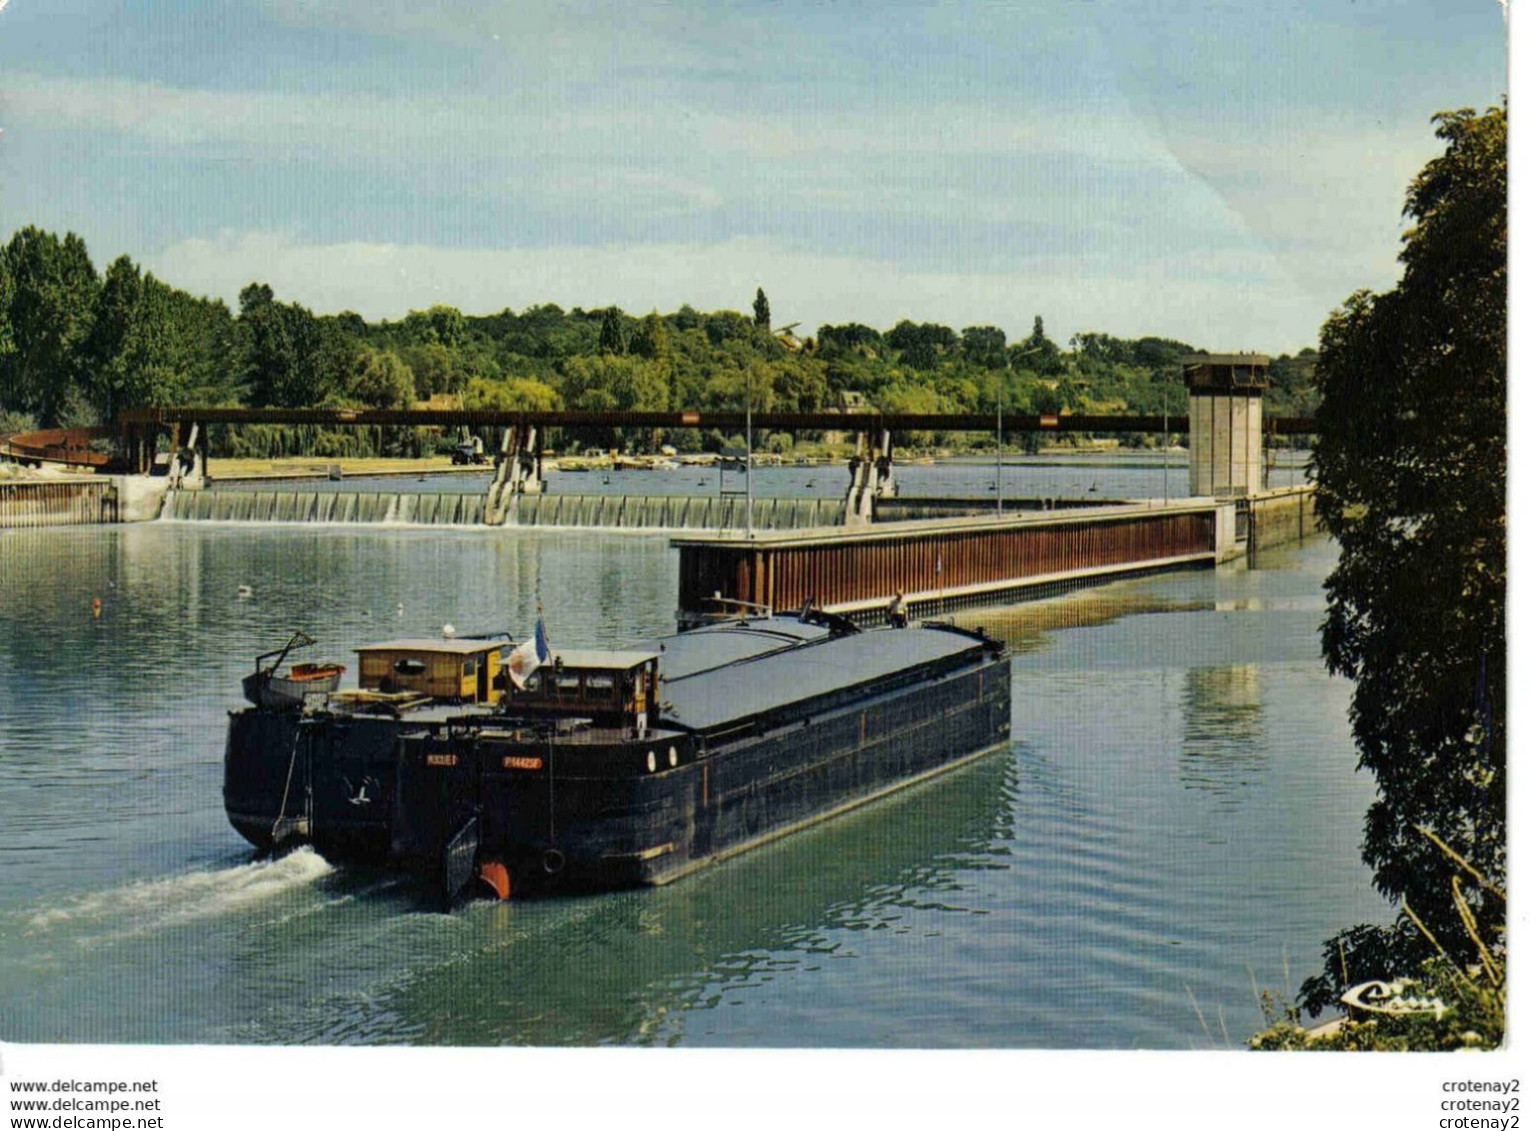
[678,508,1216,612]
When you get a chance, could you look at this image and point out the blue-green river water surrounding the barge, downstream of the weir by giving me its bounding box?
[0,465,1385,1048]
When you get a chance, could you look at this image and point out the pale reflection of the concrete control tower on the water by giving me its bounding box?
[1180,664,1268,805]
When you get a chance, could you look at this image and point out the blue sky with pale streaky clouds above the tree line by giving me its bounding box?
[0,0,1507,354]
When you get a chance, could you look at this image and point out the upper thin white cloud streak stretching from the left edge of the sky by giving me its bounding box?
[0,70,1143,161]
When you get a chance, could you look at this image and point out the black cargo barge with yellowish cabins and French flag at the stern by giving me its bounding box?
[223,608,1010,904]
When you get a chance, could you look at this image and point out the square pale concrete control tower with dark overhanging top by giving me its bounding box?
[1180,354,1270,499]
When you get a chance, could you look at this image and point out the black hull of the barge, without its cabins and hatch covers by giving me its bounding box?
[225,618,1010,892]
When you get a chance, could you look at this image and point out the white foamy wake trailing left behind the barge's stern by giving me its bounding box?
[28,848,335,941]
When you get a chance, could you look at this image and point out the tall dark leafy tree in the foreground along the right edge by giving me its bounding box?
[1302,109,1507,1012]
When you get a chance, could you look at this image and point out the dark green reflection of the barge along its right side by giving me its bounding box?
[307,758,1013,1045]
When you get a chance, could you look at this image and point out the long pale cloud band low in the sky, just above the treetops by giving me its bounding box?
[145,233,1336,350]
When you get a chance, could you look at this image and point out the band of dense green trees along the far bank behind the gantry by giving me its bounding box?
[0,228,1316,456]
